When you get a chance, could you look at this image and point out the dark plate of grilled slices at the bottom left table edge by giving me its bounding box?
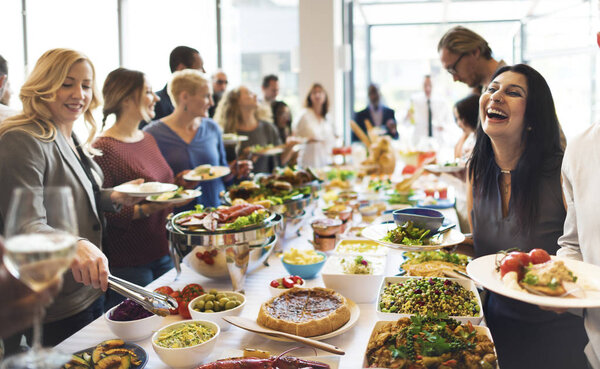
[61,339,148,369]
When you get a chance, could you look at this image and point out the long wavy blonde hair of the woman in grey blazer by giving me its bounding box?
[0,49,101,153]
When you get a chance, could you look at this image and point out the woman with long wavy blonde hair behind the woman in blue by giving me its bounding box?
[215,86,297,173]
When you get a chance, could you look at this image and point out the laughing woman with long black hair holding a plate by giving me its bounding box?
[467,64,587,369]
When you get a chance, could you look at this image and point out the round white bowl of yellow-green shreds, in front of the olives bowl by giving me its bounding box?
[152,320,221,369]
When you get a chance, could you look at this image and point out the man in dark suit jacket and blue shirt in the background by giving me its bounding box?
[352,83,398,142]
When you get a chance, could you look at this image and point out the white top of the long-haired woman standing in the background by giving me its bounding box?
[294,109,335,168]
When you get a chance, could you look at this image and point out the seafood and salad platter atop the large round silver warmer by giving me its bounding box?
[171,204,275,233]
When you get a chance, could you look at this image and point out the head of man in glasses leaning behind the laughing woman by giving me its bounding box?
[438,26,506,94]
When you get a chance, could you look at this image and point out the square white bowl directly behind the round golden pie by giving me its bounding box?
[321,255,386,304]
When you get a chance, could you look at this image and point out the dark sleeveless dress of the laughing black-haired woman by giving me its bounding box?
[471,156,587,369]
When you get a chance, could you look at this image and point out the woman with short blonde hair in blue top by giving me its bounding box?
[144,69,249,208]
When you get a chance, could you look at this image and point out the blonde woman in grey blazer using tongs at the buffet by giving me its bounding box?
[0,49,141,351]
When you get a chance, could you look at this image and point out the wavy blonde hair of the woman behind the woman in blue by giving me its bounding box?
[214,86,273,133]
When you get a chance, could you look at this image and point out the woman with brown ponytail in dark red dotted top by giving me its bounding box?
[93,68,189,309]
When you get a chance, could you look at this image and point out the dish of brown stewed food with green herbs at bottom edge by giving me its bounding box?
[362,316,497,369]
